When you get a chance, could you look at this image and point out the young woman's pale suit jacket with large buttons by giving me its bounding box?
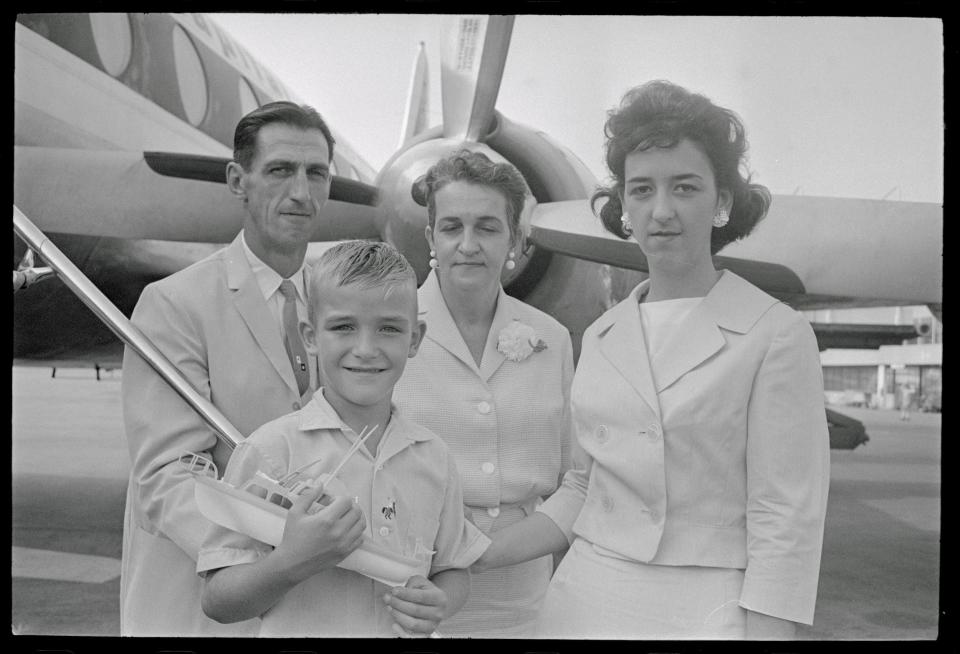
[541,271,830,624]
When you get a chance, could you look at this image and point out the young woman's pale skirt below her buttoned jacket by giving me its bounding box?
[535,538,746,640]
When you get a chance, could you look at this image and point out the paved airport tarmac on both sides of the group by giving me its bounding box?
[11,367,941,641]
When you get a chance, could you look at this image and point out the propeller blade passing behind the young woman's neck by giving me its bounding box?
[529,200,805,295]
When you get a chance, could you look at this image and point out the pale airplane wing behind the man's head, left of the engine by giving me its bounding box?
[14,146,379,243]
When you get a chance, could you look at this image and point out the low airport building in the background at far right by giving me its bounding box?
[804,306,943,411]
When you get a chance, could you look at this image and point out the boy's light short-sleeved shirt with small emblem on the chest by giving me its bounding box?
[197,389,490,635]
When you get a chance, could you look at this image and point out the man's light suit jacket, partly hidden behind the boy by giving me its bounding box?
[120,234,316,636]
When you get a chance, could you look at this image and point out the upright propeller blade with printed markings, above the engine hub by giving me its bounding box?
[440,16,514,142]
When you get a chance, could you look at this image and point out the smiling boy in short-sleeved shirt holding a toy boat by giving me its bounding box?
[197,241,489,637]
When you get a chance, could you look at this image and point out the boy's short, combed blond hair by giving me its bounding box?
[307,240,417,318]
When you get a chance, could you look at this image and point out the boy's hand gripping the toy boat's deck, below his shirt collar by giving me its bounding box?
[274,488,366,582]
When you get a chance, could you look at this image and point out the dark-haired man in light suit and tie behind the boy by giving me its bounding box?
[120,102,334,636]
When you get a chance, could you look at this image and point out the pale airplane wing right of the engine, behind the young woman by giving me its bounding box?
[530,196,943,309]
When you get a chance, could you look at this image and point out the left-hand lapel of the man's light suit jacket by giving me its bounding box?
[224,238,300,397]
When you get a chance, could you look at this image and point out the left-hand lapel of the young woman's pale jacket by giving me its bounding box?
[599,281,660,418]
